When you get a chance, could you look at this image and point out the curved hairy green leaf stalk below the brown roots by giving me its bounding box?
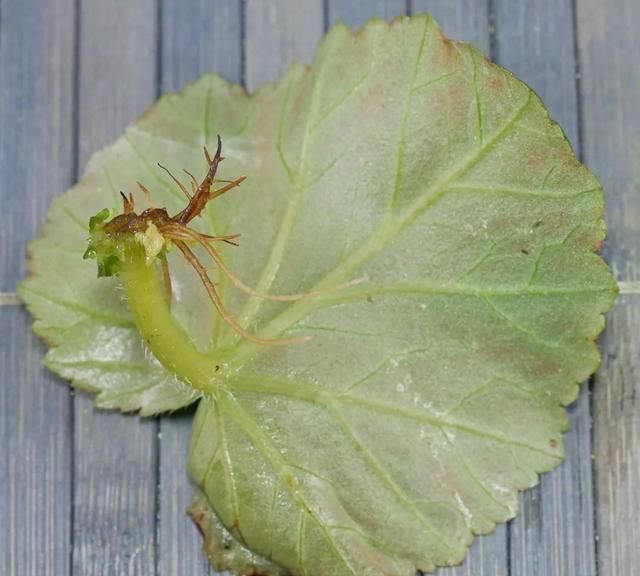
[118,242,216,394]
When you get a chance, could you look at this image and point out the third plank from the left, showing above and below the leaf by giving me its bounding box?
[158,0,242,576]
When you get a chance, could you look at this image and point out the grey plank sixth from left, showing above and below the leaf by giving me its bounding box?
[410,5,509,576]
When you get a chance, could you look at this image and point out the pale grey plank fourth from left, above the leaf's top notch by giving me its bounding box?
[244,0,324,90]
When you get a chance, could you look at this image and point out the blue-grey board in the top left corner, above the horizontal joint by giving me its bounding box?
[0,0,74,292]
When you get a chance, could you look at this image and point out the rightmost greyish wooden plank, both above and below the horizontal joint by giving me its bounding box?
[577,0,640,576]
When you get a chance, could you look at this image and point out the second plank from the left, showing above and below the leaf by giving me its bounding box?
[73,0,157,576]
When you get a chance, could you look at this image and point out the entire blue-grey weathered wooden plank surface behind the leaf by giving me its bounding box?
[0,0,640,576]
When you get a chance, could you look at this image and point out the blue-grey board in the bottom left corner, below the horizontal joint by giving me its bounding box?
[0,306,72,576]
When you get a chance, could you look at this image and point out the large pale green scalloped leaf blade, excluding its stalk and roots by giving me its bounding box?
[21,16,616,575]
